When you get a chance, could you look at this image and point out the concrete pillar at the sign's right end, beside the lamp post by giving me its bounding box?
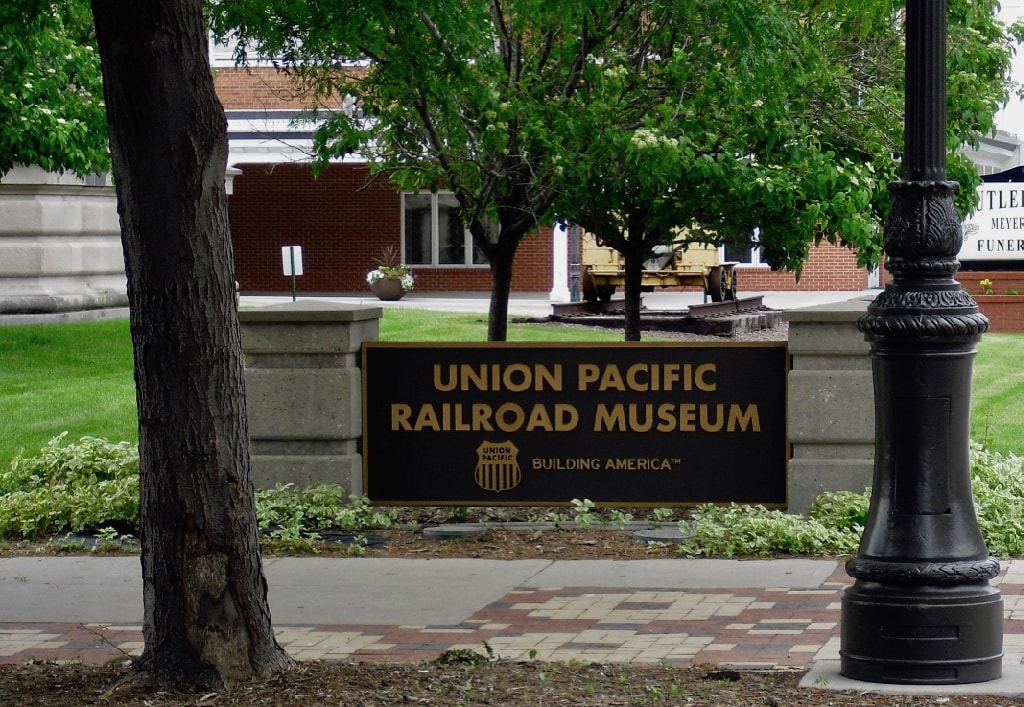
[785,297,874,513]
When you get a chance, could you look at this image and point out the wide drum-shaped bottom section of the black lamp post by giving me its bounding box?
[840,580,1002,684]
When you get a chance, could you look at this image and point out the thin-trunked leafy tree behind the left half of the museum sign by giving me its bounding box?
[214,0,643,340]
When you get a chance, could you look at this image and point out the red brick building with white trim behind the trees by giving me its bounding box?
[212,57,878,299]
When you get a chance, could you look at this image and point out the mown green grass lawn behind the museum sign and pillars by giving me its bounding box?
[0,309,1024,465]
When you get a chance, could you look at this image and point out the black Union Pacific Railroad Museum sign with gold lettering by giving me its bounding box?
[362,342,788,506]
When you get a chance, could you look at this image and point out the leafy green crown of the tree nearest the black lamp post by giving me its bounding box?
[563,0,898,267]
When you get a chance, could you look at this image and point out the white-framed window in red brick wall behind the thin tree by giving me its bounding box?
[401,192,487,267]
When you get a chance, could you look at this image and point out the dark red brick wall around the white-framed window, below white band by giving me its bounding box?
[228,163,552,293]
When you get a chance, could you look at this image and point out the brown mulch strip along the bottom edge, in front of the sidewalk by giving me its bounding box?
[0,656,1007,707]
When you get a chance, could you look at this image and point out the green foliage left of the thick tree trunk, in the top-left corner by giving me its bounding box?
[0,0,110,175]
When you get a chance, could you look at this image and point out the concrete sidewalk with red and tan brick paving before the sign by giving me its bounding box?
[0,555,1024,694]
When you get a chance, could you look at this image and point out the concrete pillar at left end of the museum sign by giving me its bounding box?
[239,300,383,495]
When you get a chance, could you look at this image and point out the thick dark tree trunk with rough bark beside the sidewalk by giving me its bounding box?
[92,0,291,684]
